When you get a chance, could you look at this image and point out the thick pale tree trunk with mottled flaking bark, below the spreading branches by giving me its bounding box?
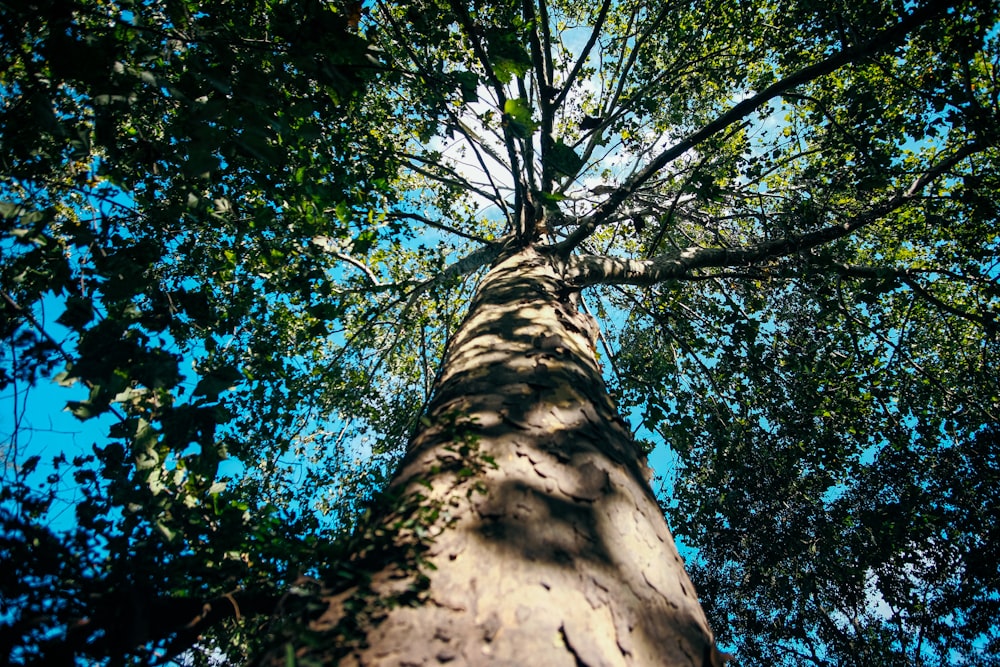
[266,249,721,667]
